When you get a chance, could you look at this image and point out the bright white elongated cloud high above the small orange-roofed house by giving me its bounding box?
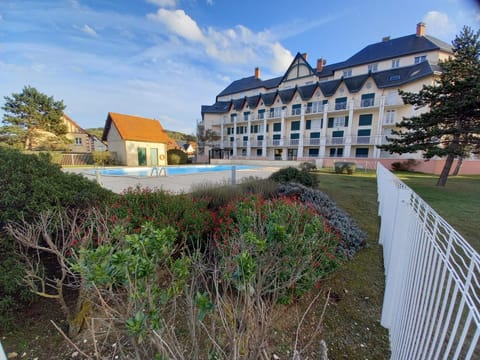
[147,9,204,41]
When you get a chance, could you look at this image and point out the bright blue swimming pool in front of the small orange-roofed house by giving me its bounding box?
[89,165,259,177]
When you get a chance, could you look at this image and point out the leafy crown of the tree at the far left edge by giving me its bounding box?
[0,86,67,150]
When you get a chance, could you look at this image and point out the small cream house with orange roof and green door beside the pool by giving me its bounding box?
[102,112,174,166]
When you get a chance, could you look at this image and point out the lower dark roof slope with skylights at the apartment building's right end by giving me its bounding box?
[372,61,436,89]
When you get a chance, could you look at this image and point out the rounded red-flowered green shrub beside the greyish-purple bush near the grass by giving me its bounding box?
[213,196,343,303]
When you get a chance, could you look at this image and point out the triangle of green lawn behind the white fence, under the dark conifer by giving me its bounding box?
[396,172,480,251]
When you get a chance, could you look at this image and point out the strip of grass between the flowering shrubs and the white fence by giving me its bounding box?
[318,170,390,359]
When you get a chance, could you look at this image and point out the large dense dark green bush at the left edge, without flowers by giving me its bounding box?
[0,148,113,328]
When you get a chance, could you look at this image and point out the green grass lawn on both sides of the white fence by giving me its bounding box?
[318,169,480,359]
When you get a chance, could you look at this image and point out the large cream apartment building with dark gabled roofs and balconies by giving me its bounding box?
[198,23,453,160]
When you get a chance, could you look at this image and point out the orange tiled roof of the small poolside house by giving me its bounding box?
[107,112,171,144]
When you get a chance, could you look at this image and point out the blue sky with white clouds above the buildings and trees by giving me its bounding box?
[0,0,480,134]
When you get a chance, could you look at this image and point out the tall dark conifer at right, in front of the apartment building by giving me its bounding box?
[379,27,480,186]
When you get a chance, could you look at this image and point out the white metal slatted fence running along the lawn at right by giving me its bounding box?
[377,164,480,360]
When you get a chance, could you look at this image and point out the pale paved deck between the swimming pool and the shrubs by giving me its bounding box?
[63,167,279,194]
